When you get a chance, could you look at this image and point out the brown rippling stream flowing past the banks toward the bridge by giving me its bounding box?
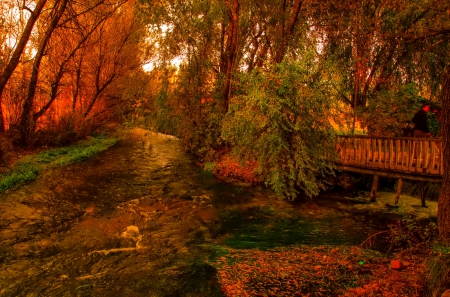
[0,129,398,297]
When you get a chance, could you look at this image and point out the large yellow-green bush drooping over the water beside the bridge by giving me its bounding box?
[222,57,335,199]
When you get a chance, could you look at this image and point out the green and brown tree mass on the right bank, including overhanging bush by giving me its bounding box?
[139,0,450,198]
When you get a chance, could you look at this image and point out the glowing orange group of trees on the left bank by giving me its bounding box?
[0,0,151,145]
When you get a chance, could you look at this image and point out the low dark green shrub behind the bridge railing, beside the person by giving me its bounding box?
[357,83,423,136]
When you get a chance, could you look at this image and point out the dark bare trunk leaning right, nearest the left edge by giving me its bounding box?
[0,0,47,132]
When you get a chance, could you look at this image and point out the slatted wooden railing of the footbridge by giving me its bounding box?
[336,135,444,175]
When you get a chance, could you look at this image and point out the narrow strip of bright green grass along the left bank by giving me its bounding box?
[0,135,117,193]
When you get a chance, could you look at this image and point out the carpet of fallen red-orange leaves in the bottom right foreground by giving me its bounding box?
[212,246,424,296]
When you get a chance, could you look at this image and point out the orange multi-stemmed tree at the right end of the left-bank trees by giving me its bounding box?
[64,1,143,135]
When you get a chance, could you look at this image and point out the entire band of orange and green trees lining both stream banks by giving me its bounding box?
[0,0,450,206]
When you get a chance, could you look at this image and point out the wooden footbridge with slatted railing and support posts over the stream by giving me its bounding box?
[336,135,444,206]
